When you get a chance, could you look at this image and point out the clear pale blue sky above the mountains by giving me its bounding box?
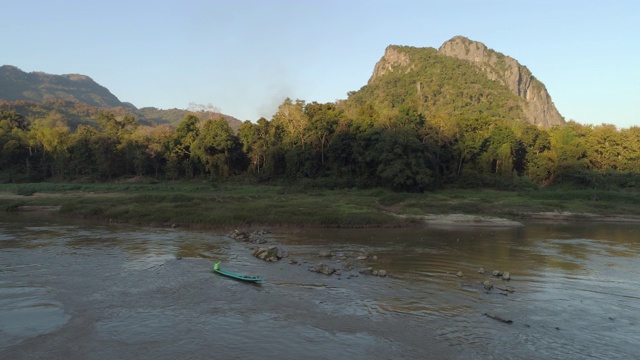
[0,0,640,128]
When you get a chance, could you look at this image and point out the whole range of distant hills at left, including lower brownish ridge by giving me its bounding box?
[0,65,242,131]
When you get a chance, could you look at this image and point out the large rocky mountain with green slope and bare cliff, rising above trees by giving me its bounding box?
[347,36,564,128]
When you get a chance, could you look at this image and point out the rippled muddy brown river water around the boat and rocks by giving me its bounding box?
[0,213,640,359]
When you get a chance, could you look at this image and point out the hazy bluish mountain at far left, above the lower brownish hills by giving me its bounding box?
[0,65,135,109]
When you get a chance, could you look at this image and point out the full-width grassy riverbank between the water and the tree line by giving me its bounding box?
[0,182,640,227]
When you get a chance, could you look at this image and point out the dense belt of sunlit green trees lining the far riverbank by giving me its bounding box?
[0,93,640,192]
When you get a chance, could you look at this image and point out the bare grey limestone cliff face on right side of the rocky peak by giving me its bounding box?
[438,36,564,128]
